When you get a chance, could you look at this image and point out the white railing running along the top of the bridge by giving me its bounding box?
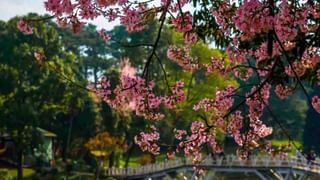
[105,155,320,176]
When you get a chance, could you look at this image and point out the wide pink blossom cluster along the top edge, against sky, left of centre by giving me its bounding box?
[45,0,146,32]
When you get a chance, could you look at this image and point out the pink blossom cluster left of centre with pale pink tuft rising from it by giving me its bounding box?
[94,59,186,120]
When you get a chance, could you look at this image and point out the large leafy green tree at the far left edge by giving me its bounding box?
[0,15,95,158]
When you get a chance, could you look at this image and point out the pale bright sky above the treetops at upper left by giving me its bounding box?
[0,0,119,30]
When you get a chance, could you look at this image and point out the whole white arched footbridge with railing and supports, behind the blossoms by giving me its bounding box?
[104,155,320,180]
